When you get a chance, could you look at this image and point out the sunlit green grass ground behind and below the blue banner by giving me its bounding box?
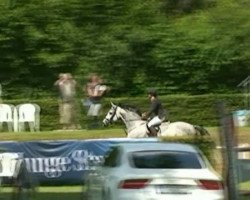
[0,127,250,200]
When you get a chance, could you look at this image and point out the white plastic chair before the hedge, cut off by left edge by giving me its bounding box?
[0,104,15,131]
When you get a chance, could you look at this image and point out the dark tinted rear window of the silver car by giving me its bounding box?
[131,151,202,169]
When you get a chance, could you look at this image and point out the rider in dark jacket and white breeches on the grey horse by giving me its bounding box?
[142,89,166,137]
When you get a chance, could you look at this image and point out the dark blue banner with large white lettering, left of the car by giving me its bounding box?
[0,138,157,185]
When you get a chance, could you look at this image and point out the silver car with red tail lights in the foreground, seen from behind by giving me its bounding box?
[85,142,224,200]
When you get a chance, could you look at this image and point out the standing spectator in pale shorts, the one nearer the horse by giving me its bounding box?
[84,74,107,128]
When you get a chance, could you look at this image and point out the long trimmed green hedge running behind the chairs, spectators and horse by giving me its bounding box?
[3,94,244,130]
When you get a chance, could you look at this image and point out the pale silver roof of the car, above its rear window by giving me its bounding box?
[115,142,197,153]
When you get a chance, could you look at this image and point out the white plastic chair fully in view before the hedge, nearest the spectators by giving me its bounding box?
[16,103,40,132]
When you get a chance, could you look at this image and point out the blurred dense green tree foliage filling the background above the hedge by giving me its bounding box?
[0,0,250,95]
